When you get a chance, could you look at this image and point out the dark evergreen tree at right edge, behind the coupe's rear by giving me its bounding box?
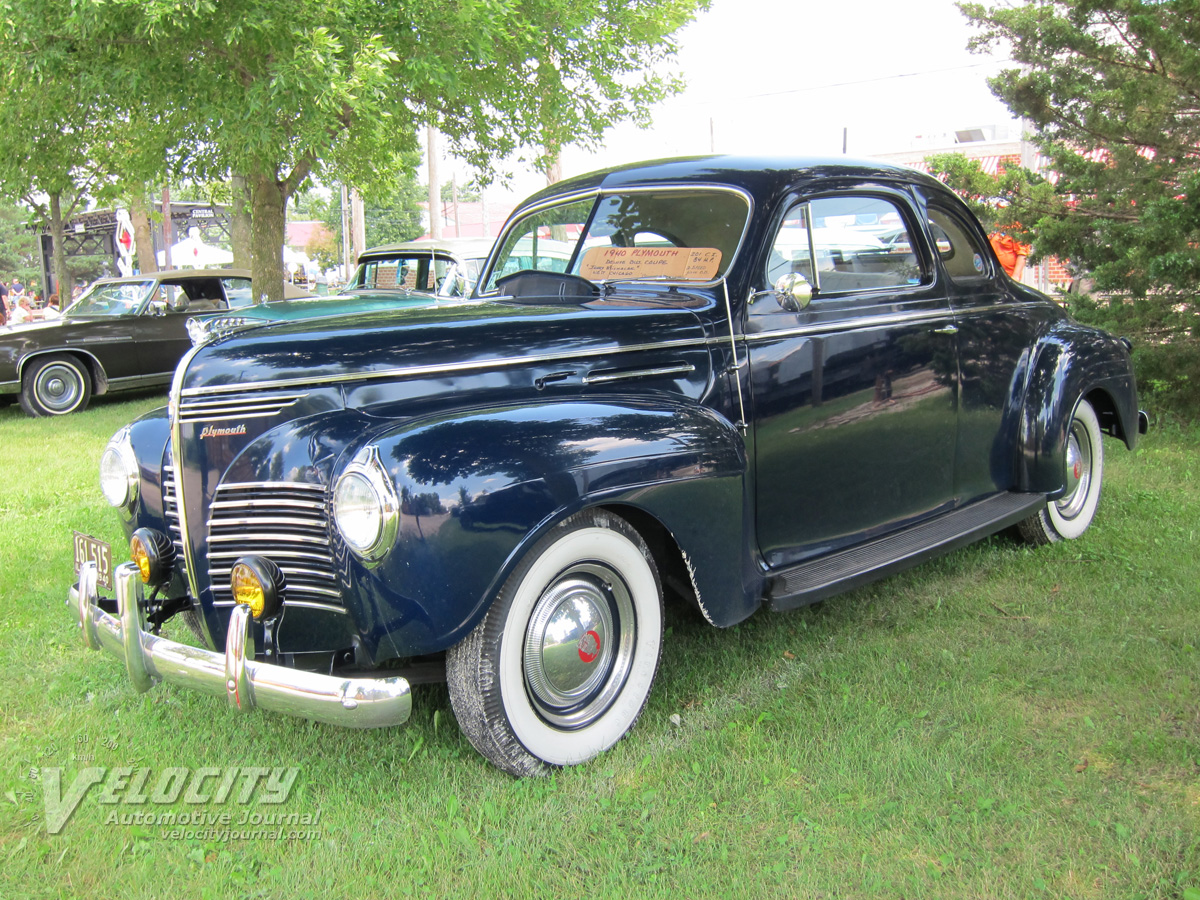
[960,0,1200,420]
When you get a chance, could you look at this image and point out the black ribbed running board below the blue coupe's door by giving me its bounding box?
[764,493,1046,611]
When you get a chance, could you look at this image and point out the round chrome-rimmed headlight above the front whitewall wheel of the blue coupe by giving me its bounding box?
[330,446,400,566]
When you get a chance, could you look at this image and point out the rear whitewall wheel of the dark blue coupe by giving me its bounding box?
[1019,400,1104,545]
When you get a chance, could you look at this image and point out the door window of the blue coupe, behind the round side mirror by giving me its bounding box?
[767,196,925,296]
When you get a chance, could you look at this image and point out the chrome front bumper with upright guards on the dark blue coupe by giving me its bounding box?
[67,563,413,728]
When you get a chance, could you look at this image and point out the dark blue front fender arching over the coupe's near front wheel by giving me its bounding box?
[335,398,746,659]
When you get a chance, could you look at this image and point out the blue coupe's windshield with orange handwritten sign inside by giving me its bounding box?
[486,188,750,290]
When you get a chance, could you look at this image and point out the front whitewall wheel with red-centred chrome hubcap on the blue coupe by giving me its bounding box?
[446,510,662,775]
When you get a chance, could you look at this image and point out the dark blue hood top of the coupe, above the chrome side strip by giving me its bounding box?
[179,295,727,394]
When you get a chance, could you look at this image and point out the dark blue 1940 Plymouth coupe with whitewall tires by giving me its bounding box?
[70,157,1146,774]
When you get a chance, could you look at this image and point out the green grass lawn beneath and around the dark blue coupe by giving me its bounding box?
[0,395,1200,900]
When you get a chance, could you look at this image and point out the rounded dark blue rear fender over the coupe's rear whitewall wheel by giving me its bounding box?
[1019,322,1139,497]
